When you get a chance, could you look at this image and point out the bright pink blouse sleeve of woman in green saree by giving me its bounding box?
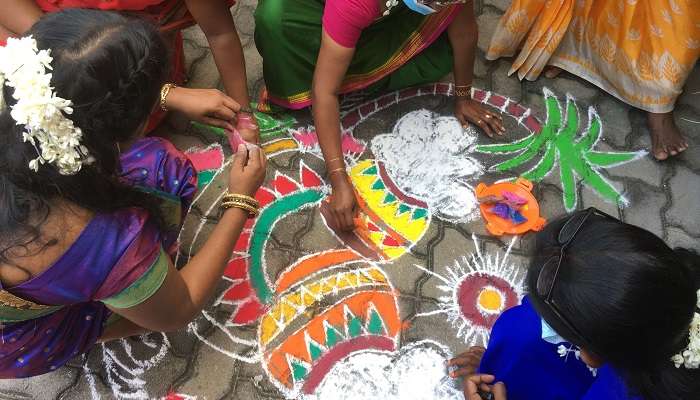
[323,0,379,48]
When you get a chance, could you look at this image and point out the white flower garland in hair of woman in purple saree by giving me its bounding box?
[0,36,94,175]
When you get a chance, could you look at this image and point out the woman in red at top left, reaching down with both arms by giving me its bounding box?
[0,0,259,143]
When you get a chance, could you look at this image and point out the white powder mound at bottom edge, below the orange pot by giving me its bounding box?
[302,340,464,400]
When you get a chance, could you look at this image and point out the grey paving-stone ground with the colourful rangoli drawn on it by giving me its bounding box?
[0,0,700,399]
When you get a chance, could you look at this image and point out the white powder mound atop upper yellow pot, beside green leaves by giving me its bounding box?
[372,110,484,222]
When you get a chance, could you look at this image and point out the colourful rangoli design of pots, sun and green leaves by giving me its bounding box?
[75,84,640,400]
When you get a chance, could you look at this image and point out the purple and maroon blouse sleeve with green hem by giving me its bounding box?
[95,210,170,308]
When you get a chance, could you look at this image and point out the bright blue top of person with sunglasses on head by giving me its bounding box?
[479,297,641,400]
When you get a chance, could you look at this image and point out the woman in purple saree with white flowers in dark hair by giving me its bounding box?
[0,9,266,378]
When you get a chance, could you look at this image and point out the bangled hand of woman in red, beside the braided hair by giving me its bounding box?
[165,87,245,130]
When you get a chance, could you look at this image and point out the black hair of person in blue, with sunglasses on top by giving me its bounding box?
[527,214,700,400]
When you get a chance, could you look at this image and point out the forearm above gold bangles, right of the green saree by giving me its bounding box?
[447,2,479,86]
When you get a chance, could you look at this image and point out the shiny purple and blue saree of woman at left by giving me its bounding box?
[0,138,197,378]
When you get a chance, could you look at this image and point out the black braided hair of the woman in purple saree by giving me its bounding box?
[0,9,168,262]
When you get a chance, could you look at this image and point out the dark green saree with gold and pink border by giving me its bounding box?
[255,0,460,109]
